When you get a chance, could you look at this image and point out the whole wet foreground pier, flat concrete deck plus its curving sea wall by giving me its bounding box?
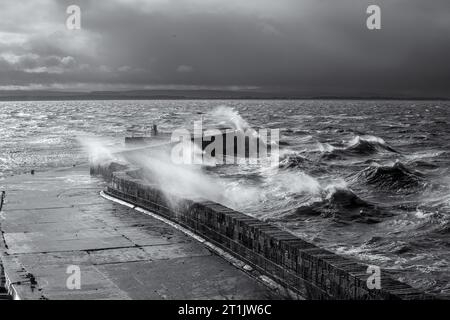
[0,134,434,300]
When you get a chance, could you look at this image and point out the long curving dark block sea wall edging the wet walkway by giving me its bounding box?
[91,163,432,299]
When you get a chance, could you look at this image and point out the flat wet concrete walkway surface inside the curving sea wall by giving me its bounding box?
[0,167,280,299]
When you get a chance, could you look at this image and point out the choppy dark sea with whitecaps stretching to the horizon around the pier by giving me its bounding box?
[0,100,450,295]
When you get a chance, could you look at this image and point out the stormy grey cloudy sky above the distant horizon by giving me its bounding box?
[0,0,450,96]
